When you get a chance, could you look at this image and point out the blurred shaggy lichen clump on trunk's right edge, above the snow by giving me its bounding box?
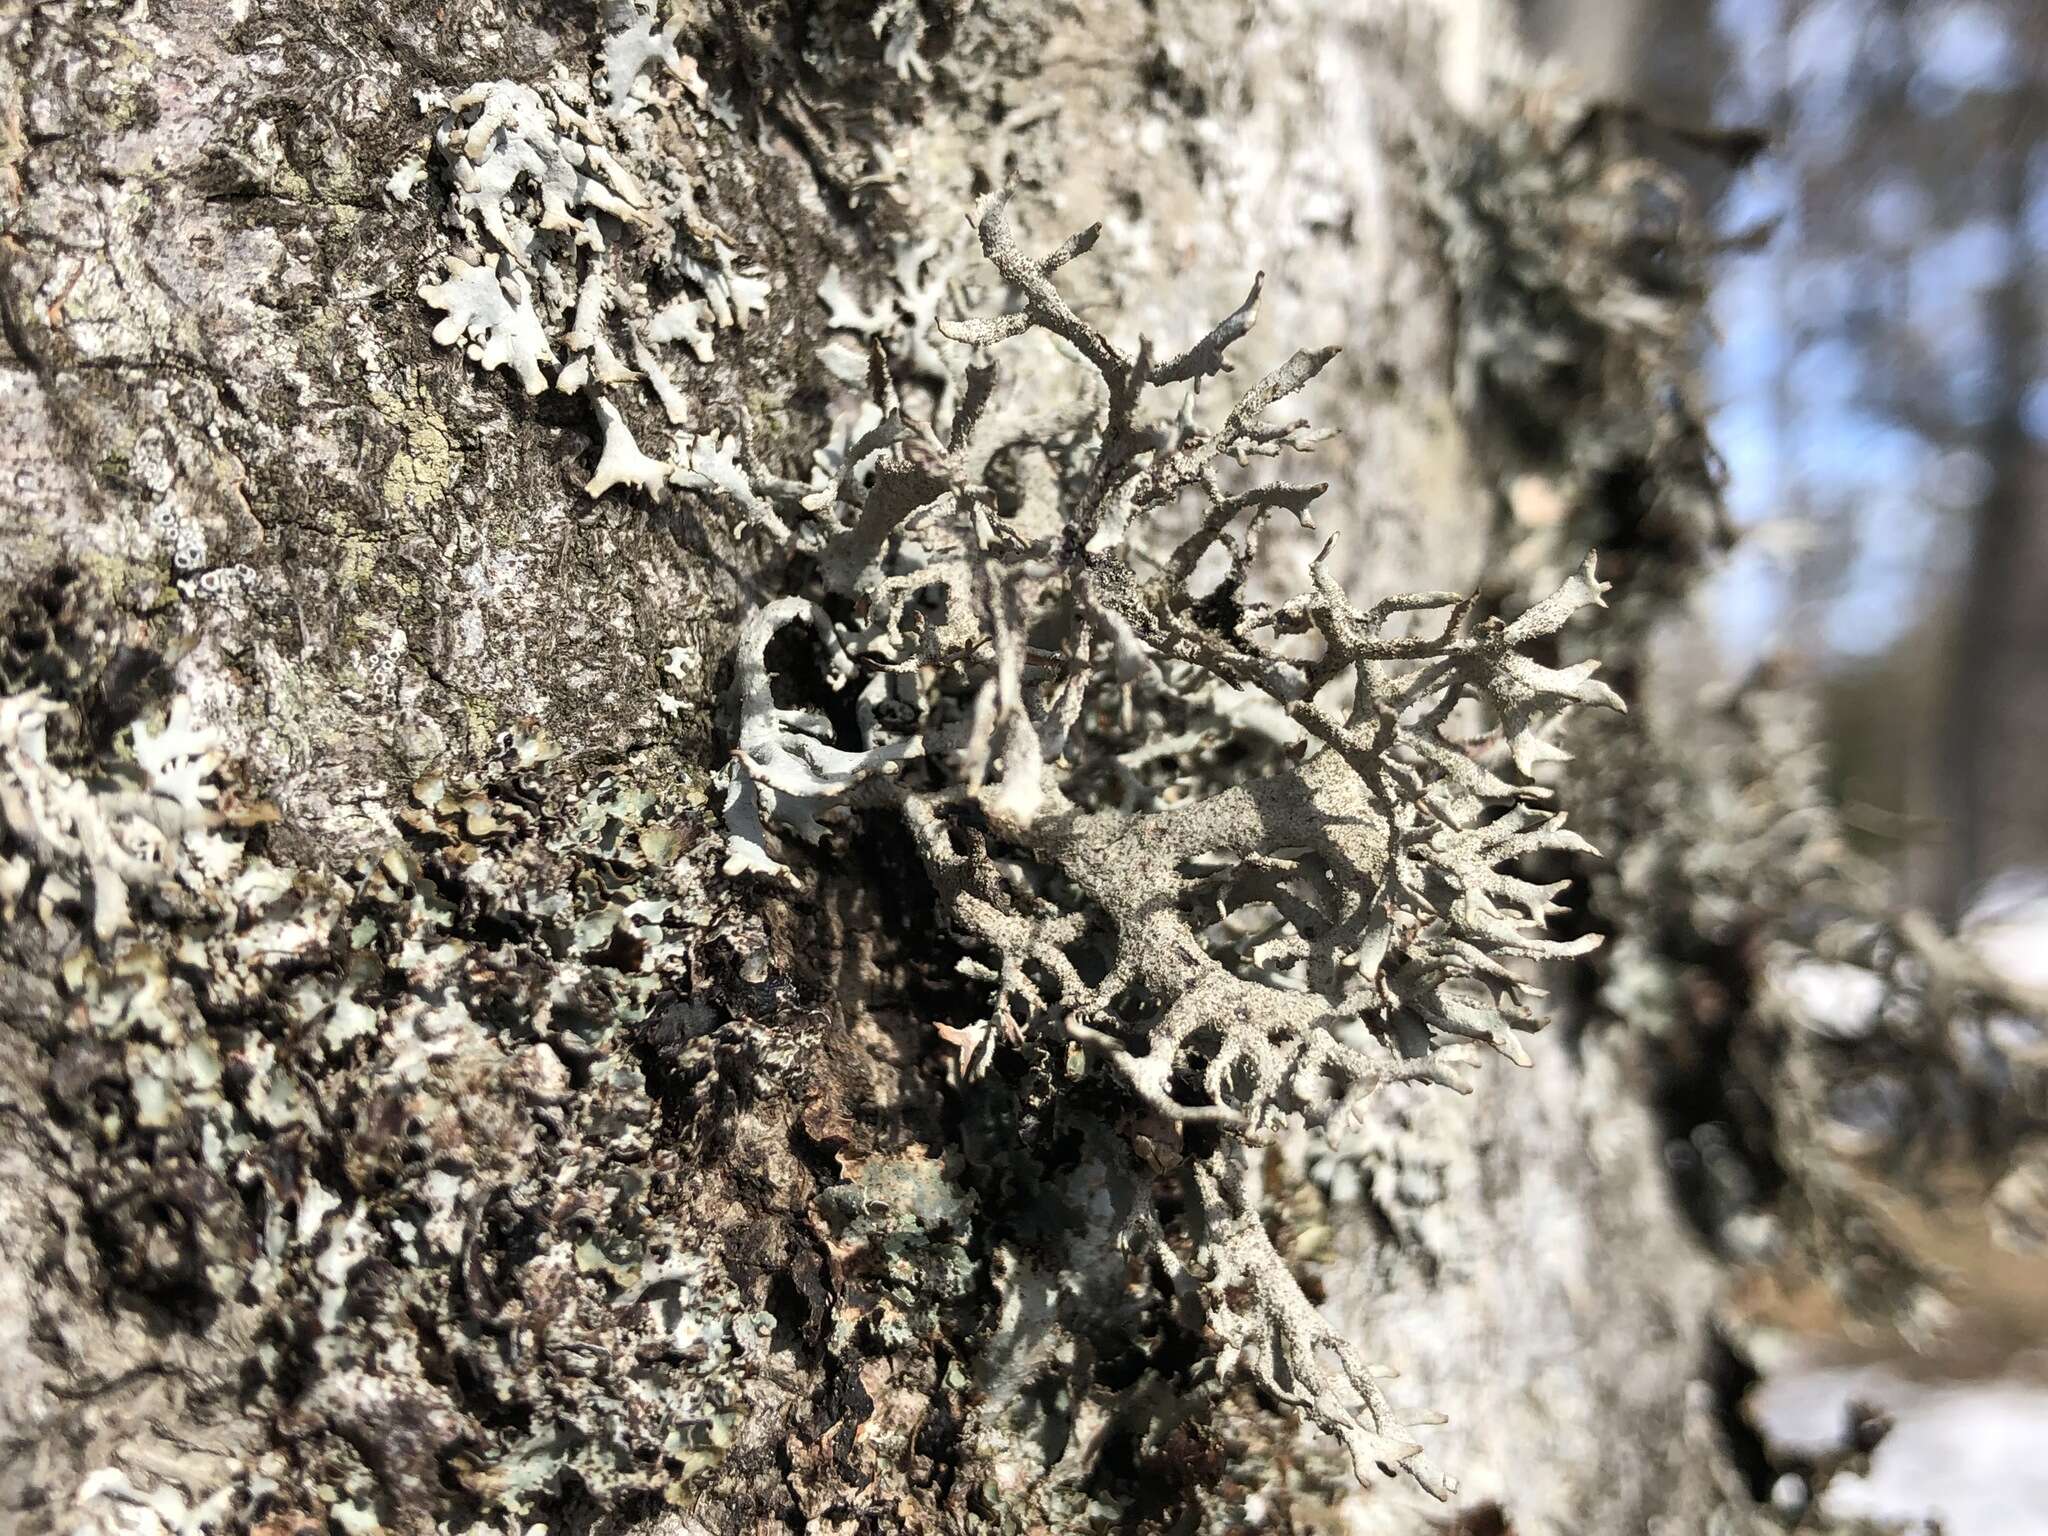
[1593,688,2048,1339]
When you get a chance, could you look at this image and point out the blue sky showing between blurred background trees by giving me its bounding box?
[1708,0,2048,672]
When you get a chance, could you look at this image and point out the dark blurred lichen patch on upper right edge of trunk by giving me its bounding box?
[1417,96,1731,608]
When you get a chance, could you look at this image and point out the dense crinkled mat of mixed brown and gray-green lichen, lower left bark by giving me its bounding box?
[0,655,823,1532]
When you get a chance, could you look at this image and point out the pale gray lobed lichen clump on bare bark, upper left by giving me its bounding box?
[411,4,784,537]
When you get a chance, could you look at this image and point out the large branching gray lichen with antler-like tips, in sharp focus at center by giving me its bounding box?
[727,193,1620,1495]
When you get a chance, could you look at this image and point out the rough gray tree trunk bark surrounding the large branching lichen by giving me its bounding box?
[0,0,1957,1536]
